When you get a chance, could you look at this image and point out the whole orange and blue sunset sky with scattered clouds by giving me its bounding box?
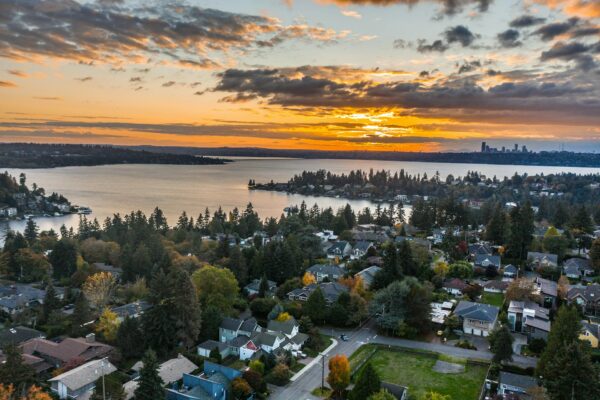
[0,0,600,152]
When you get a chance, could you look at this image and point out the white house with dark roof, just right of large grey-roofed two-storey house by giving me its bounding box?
[508,301,550,340]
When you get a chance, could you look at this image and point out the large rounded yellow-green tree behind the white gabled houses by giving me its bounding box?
[192,265,239,314]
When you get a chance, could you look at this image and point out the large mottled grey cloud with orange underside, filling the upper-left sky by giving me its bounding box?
[0,0,343,67]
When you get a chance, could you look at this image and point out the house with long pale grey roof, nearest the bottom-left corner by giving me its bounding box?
[48,359,117,399]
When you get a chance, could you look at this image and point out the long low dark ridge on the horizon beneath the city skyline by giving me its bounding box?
[127,146,600,168]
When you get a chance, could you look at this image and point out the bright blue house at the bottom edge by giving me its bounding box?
[166,361,242,400]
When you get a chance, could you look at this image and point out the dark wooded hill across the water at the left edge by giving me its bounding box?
[0,143,229,168]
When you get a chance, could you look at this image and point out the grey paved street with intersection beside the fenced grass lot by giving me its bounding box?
[270,321,537,400]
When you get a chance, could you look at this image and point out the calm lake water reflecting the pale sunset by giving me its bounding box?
[0,159,600,240]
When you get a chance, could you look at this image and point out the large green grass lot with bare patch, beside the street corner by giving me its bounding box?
[351,346,488,400]
